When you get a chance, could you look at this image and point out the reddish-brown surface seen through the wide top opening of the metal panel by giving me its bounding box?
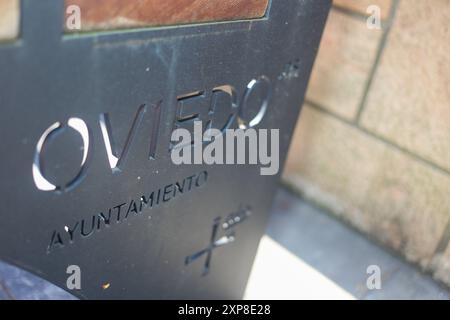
[65,0,269,32]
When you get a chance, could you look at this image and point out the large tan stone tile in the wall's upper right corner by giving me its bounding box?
[362,0,450,172]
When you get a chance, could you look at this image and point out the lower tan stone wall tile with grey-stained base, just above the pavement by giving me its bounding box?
[284,106,450,267]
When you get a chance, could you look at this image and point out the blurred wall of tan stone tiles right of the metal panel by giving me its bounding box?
[284,0,450,286]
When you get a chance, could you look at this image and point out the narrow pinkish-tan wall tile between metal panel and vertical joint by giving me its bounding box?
[307,10,382,119]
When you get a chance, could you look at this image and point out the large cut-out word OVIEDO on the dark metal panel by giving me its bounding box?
[32,76,278,193]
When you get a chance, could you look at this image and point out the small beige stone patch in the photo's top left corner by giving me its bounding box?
[0,0,20,41]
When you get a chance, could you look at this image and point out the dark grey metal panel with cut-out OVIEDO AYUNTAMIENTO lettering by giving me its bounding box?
[0,0,330,298]
